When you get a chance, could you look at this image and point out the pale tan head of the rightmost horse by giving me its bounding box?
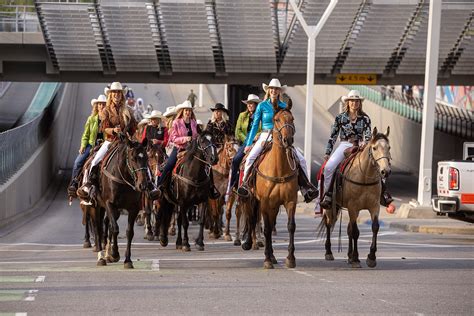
[369,127,392,178]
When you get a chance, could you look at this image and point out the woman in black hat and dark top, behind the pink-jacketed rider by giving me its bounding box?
[205,103,234,149]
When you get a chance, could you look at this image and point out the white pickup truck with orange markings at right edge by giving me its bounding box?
[432,143,474,223]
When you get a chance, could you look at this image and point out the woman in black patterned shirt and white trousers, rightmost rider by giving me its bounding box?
[320,90,393,209]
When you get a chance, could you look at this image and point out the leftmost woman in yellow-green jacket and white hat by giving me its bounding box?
[68,94,107,192]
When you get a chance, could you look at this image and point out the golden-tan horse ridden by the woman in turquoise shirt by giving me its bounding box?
[242,108,299,269]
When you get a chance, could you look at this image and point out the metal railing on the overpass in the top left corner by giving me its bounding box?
[0,5,41,32]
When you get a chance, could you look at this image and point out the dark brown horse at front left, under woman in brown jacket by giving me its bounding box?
[97,136,148,269]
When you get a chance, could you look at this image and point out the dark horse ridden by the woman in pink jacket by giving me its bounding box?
[160,133,217,252]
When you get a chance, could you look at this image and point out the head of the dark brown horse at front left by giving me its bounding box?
[126,138,148,191]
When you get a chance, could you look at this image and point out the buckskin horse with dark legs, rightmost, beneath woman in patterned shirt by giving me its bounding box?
[318,127,391,268]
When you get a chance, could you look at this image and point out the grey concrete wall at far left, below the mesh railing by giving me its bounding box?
[0,84,77,227]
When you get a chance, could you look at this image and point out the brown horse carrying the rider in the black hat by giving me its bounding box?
[207,136,239,239]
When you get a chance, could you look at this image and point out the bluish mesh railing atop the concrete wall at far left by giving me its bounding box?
[0,83,63,185]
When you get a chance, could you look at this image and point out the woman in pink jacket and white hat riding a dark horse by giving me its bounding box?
[157,100,220,199]
